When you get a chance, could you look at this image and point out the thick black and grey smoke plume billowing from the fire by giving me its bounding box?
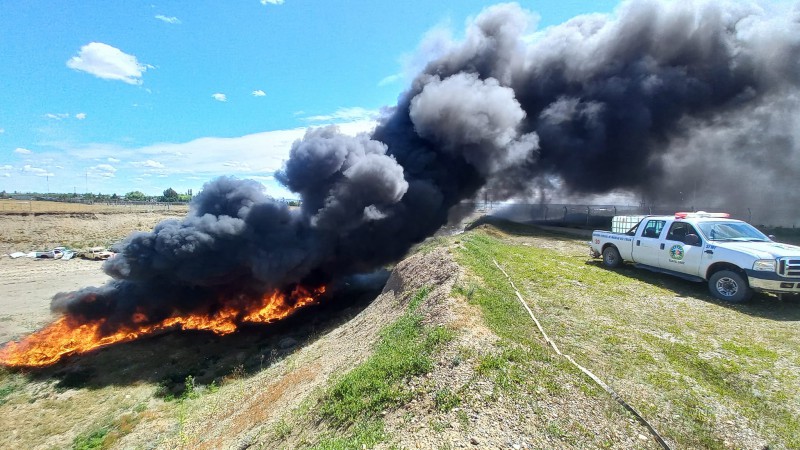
[53,1,800,328]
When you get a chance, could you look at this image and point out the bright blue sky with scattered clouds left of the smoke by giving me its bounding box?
[0,0,616,197]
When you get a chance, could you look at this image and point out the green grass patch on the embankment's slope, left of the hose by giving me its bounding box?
[314,288,453,449]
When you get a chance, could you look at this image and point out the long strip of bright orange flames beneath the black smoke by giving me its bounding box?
[0,286,325,367]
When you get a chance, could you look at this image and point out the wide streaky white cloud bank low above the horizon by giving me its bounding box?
[44,121,376,198]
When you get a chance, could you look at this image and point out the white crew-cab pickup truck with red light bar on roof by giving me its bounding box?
[589,212,800,303]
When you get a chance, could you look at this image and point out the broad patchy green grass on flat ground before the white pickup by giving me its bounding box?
[457,228,800,448]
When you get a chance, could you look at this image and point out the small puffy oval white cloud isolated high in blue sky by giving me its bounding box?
[67,42,152,84]
